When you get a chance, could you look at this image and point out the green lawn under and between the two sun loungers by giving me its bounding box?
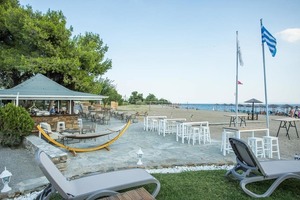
[49,170,300,200]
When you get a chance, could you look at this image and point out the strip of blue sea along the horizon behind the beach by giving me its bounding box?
[177,104,300,114]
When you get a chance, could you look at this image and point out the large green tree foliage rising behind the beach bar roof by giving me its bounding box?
[0,0,112,94]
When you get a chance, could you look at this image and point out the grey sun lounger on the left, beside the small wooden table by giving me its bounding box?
[35,151,160,200]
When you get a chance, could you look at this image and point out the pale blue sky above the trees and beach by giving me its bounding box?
[20,0,300,103]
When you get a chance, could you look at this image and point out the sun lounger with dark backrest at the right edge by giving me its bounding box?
[226,138,300,198]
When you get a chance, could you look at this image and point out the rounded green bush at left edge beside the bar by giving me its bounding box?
[0,103,34,147]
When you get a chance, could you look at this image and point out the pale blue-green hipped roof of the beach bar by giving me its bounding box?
[0,74,107,100]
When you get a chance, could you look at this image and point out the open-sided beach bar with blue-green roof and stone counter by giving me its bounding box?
[0,74,107,131]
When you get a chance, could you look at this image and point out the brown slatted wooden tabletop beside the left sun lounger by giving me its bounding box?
[101,188,155,200]
